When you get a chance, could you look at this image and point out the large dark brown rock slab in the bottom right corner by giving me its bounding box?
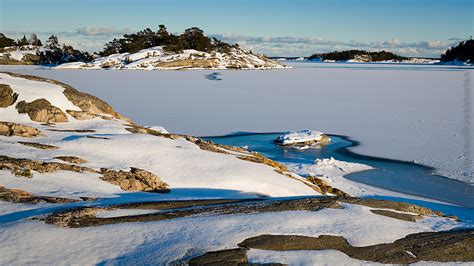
[239,229,474,264]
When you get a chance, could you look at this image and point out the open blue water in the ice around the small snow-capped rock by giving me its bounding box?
[205,133,474,209]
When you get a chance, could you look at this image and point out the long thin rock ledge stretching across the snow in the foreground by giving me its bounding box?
[39,197,443,227]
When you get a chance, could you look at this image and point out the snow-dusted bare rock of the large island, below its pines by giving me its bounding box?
[55,46,288,70]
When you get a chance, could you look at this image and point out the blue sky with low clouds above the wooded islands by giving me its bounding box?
[0,0,474,57]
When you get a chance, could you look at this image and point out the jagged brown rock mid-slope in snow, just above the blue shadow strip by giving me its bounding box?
[100,167,170,193]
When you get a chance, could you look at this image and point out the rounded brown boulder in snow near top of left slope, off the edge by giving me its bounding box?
[16,98,68,123]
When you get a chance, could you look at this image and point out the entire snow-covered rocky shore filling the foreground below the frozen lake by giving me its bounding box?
[0,73,474,265]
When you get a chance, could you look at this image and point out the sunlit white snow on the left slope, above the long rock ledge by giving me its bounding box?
[0,74,318,200]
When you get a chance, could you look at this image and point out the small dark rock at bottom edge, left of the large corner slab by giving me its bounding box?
[188,248,248,266]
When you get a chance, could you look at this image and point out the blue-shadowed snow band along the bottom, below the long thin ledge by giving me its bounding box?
[0,205,460,265]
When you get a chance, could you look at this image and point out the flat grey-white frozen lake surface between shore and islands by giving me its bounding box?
[2,63,474,185]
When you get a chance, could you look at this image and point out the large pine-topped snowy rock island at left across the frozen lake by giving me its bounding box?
[0,25,289,70]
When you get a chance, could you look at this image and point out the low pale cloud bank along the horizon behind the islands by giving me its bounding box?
[5,27,460,57]
